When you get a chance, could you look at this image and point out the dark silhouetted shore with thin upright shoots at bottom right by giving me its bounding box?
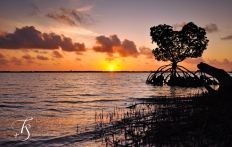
[93,93,232,147]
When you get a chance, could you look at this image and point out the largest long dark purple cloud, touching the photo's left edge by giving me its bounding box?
[0,26,85,53]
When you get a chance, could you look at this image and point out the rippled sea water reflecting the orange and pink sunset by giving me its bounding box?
[0,73,214,146]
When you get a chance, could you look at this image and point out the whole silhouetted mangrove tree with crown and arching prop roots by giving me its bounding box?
[147,22,214,86]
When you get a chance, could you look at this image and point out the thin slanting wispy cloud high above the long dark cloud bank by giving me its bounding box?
[45,13,76,26]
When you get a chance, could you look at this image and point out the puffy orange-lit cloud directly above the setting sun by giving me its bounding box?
[93,35,139,57]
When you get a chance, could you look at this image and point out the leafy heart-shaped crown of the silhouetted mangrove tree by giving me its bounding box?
[150,22,209,63]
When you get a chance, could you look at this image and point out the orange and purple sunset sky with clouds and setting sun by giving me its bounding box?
[0,0,232,71]
